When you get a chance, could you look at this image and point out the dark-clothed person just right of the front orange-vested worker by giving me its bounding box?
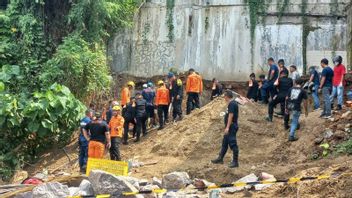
[123,97,137,145]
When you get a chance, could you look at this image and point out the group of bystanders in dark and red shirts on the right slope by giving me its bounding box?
[247,56,346,141]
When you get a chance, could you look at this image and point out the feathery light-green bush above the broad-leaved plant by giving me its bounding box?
[40,35,111,101]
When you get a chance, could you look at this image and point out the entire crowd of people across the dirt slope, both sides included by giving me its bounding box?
[79,56,346,172]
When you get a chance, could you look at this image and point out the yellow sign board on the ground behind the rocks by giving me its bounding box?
[86,158,128,176]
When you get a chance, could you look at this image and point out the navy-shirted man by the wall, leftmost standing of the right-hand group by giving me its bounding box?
[261,58,279,104]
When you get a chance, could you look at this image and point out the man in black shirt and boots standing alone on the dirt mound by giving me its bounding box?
[211,90,239,168]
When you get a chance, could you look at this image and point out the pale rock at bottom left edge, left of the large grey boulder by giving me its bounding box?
[33,182,70,198]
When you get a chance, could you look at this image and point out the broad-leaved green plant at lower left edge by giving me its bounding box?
[0,84,85,179]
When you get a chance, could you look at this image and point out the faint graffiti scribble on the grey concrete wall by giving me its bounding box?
[132,41,175,76]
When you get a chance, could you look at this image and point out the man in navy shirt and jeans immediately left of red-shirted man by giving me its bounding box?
[319,58,334,119]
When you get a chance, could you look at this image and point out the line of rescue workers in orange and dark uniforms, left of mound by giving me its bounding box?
[79,69,204,172]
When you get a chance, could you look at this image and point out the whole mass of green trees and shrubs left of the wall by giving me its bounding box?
[0,0,141,179]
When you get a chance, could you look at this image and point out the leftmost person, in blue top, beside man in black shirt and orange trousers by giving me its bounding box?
[78,109,93,173]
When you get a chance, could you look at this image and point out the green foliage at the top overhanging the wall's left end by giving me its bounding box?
[68,0,141,42]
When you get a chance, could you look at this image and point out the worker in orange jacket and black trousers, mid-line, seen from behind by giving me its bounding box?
[155,80,170,130]
